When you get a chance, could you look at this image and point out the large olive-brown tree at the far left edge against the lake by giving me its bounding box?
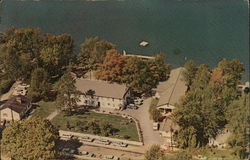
[0,28,41,78]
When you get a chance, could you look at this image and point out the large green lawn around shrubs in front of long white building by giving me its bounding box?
[52,112,139,141]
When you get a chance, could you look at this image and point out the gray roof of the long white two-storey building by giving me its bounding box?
[75,78,127,99]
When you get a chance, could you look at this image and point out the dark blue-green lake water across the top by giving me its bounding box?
[0,0,249,79]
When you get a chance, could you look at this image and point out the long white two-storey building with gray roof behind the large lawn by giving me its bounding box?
[75,78,130,109]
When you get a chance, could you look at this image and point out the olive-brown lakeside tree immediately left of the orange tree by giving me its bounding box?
[77,37,116,69]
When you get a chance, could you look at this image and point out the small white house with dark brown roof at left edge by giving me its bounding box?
[0,95,32,124]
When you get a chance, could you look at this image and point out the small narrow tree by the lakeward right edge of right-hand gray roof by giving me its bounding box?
[182,60,197,90]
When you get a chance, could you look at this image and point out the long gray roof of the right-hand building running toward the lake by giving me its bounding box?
[156,68,187,106]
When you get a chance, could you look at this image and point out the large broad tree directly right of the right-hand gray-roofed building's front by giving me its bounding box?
[173,82,226,148]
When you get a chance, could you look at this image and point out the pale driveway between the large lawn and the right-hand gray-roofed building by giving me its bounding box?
[121,98,164,147]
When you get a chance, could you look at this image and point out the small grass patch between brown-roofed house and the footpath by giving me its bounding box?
[31,101,56,118]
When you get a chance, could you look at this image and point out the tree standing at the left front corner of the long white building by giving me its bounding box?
[55,71,80,112]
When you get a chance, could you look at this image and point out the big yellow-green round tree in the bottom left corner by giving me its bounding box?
[1,118,59,160]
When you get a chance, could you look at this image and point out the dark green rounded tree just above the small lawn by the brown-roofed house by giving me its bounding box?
[28,68,50,102]
